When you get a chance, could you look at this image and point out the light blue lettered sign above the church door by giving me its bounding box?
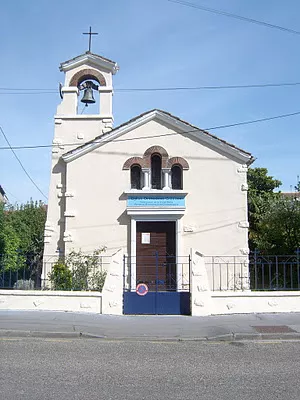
[127,196,185,207]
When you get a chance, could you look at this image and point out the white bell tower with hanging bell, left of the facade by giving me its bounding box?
[43,47,119,266]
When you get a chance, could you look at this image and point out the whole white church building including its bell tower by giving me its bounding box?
[44,52,254,312]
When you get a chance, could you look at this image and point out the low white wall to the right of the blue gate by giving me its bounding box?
[211,291,300,314]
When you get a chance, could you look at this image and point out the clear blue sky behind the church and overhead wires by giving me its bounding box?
[0,0,300,203]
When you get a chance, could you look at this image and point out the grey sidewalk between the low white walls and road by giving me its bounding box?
[0,311,300,340]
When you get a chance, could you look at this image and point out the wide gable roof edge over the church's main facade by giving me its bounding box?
[62,109,255,165]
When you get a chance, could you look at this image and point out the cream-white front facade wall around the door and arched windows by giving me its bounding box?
[65,120,248,255]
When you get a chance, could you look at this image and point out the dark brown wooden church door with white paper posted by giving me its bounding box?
[136,221,177,292]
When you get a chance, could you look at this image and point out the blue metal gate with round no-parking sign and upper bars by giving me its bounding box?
[123,252,190,315]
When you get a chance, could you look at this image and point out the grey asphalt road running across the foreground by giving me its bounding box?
[0,338,300,400]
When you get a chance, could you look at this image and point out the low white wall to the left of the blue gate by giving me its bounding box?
[0,290,102,314]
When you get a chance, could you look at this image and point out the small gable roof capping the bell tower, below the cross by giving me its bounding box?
[59,51,119,74]
